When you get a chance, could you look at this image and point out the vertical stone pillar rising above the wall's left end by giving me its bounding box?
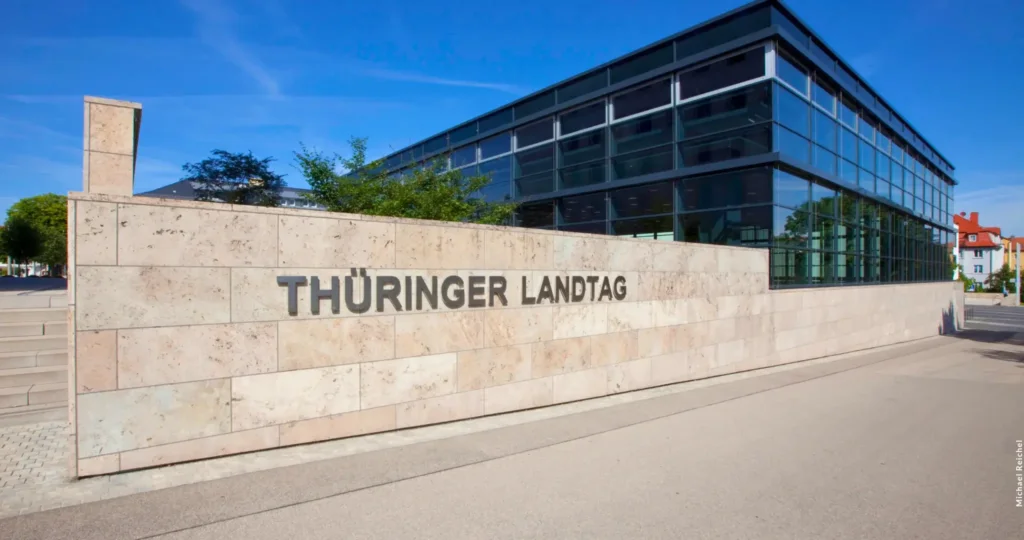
[82,96,142,196]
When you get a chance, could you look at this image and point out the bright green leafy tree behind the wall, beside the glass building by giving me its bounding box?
[295,138,516,224]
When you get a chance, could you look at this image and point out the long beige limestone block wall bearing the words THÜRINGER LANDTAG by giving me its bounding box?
[69,194,963,476]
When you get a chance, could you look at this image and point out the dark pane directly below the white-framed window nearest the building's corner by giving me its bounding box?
[679,84,771,140]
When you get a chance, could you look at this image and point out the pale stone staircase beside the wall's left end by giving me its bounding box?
[0,280,68,427]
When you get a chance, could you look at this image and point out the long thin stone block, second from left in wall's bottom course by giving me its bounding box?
[121,426,278,470]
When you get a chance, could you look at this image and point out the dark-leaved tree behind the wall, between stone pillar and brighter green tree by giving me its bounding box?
[181,150,285,206]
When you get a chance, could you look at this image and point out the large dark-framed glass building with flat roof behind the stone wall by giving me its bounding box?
[384,0,956,288]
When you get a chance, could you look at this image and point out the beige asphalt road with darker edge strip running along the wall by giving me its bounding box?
[0,323,1024,540]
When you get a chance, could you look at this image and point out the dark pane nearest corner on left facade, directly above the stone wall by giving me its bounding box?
[679,206,772,247]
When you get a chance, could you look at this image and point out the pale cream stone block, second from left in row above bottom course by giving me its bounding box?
[231,366,359,431]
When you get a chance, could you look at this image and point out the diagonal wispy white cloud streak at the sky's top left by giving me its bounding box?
[180,0,281,96]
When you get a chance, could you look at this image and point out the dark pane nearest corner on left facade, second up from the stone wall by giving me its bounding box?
[679,168,772,211]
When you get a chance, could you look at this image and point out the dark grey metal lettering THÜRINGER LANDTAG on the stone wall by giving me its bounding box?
[278,268,626,315]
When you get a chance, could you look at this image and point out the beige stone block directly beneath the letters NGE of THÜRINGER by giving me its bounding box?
[394,311,484,358]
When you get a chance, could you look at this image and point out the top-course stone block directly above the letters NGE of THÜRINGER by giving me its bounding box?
[395,223,485,269]
